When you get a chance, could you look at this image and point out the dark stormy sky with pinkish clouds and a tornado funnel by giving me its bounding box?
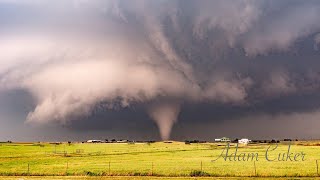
[0,0,320,141]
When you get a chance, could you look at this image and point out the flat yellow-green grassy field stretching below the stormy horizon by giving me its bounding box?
[0,142,320,178]
